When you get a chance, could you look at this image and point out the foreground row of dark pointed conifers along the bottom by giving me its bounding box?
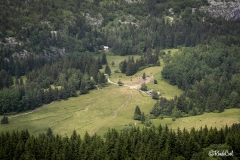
[0,124,240,159]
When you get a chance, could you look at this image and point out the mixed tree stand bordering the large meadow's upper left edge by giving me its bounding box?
[0,54,107,114]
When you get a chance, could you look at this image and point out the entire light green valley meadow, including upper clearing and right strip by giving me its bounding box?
[0,50,240,136]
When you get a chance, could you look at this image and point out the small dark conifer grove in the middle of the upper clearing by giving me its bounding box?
[119,53,160,76]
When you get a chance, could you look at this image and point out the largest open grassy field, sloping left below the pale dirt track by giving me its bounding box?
[0,85,155,135]
